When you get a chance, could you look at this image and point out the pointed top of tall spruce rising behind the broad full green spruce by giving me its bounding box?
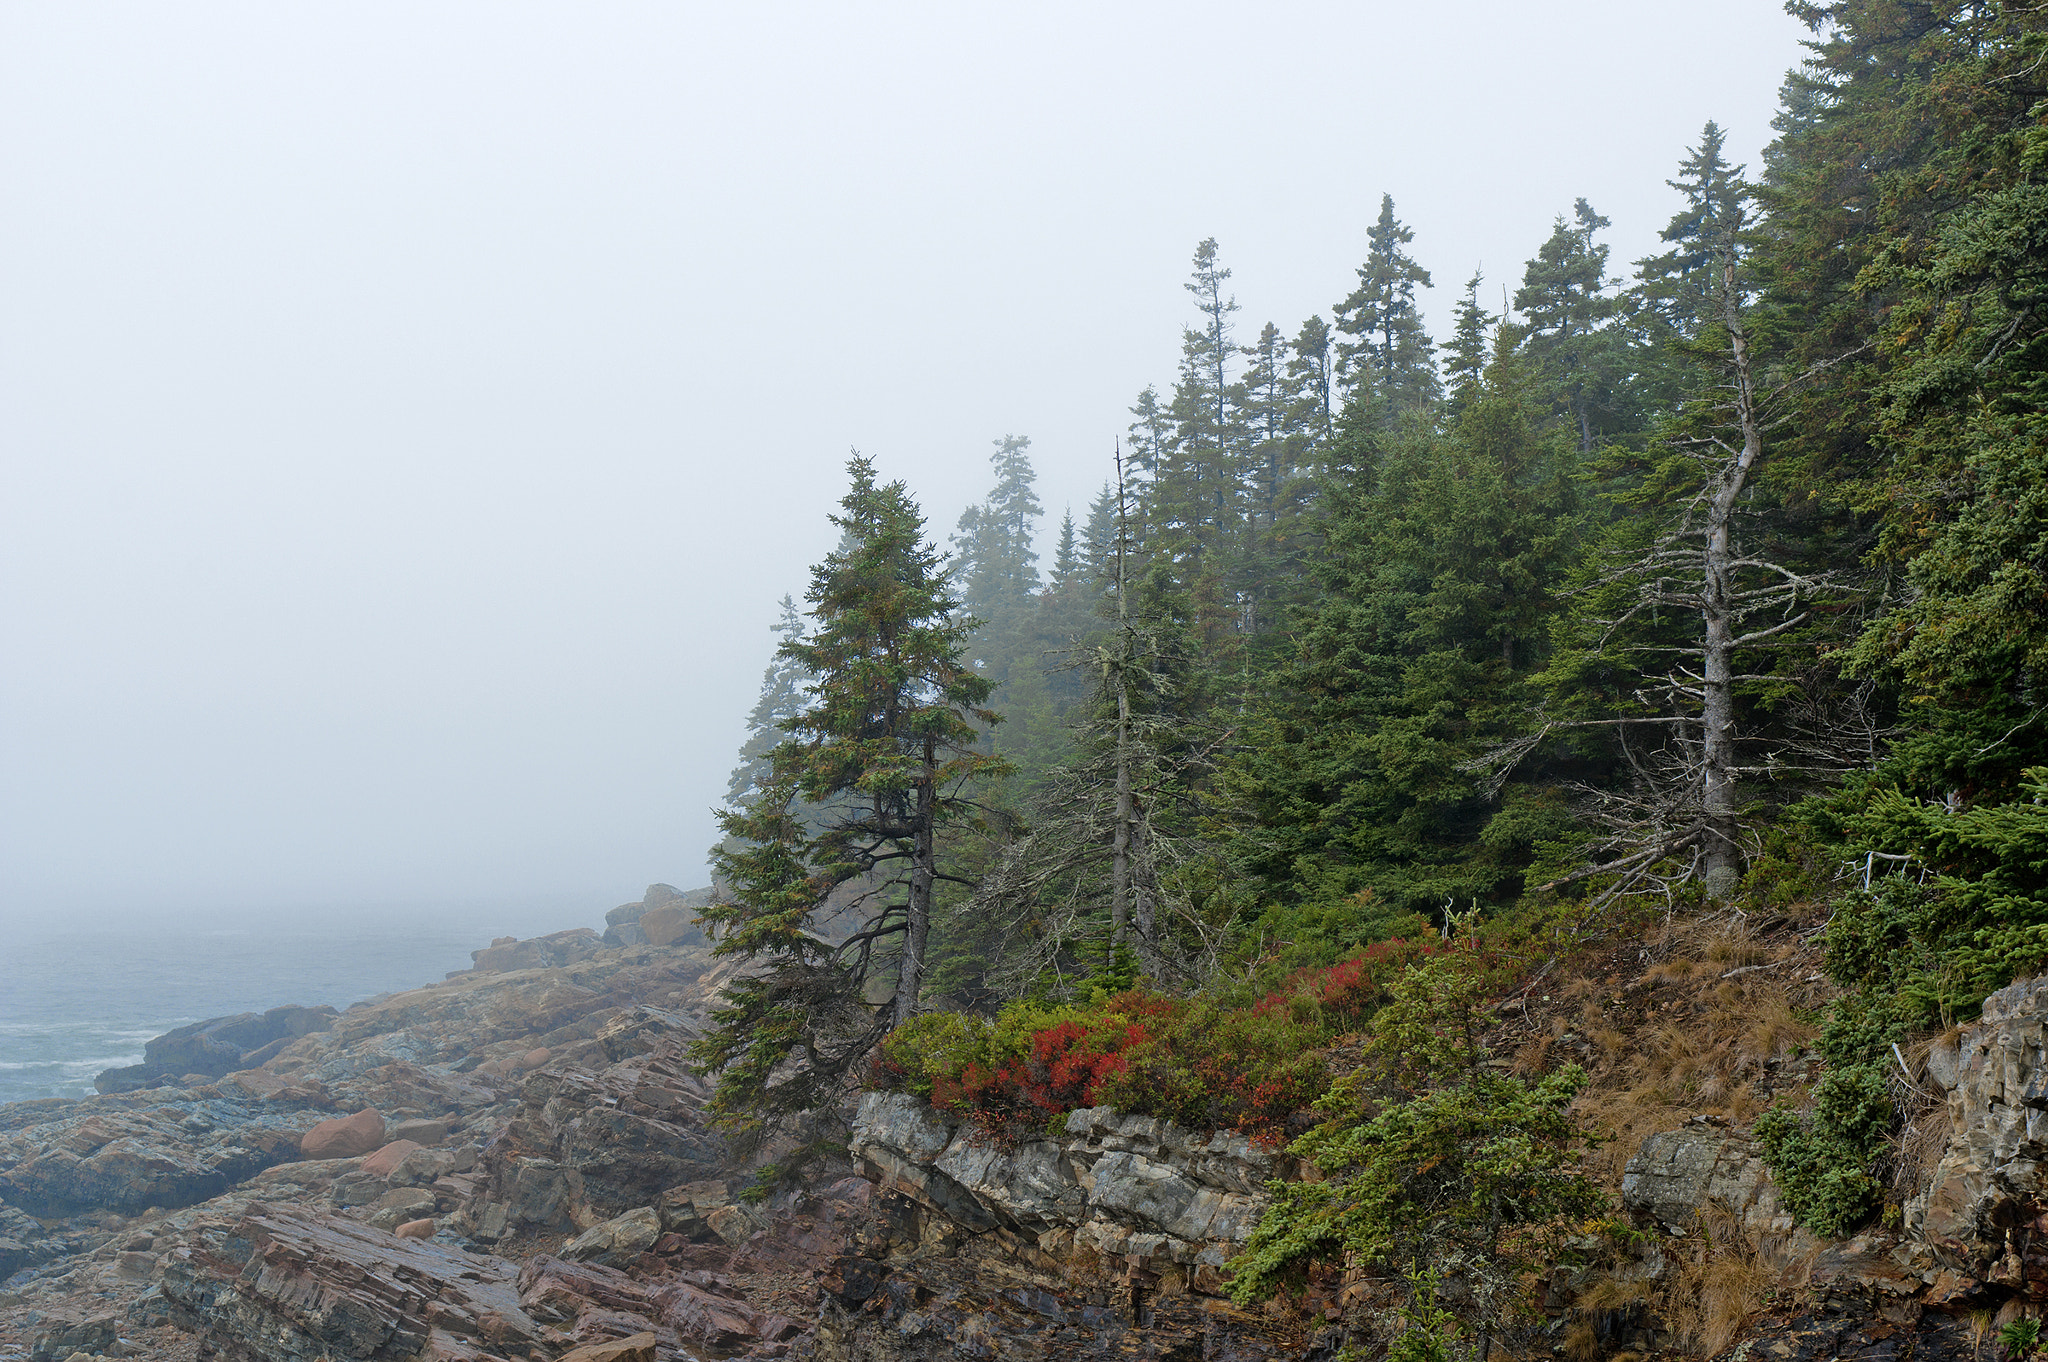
[1337,195,1442,420]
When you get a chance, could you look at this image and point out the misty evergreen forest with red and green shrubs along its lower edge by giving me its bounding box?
[700,0,2048,1351]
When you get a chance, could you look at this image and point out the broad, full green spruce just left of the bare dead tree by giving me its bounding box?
[1229,391,1577,929]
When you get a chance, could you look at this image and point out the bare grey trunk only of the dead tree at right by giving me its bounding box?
[1700,258,1763,899]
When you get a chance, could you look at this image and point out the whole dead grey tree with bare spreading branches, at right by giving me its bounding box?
[1473,201,1882,901]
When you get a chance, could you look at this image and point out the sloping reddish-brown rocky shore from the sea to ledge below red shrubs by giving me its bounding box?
[0,887,1298,1362]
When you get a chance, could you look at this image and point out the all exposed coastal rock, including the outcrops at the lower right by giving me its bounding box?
[12,887,2048,1362]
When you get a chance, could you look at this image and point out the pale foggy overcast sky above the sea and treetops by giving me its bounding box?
[0,0,1826,926]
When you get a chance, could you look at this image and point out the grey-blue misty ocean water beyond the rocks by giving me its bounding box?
[0,905,604,1102]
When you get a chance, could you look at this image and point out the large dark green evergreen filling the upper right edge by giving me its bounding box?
[1763,0,2048,809]
